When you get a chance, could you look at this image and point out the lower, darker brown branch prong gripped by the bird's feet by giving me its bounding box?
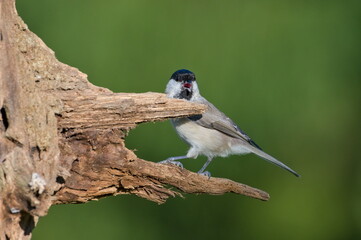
[56,130,269,203]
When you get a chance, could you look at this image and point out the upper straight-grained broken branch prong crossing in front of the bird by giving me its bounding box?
[58,89,204,130]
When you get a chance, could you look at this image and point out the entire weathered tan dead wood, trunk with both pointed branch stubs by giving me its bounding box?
[0,0,269,239]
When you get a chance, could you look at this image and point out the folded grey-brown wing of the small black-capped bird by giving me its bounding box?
[189,100,261,150]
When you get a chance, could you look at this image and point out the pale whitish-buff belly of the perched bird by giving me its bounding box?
[172,119,232,157]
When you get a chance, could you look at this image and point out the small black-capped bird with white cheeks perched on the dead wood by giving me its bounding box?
[160,69,299,177]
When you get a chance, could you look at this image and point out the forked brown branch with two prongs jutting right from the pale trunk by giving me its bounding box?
[56,88,269,203]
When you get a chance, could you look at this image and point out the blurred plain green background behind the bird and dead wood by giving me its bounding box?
[17,0,361,240]
